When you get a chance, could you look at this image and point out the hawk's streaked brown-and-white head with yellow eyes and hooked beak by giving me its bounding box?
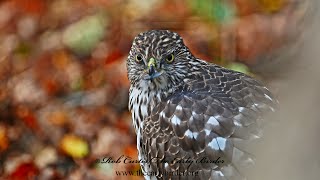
[127,30,192,89]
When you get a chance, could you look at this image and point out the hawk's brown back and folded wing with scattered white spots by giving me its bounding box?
[141,60,276,180]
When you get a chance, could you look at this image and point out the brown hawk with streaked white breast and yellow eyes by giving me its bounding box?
[127,30,277,180]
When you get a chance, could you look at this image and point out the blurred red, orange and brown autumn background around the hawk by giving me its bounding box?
[0,0,320,180]
